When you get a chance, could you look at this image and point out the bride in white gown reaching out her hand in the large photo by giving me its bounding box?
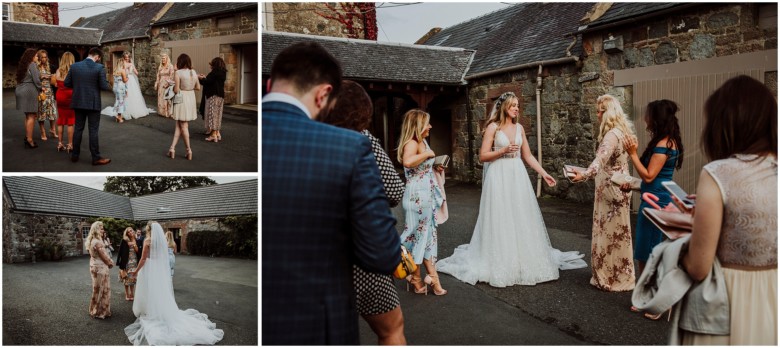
[436,92,587,287]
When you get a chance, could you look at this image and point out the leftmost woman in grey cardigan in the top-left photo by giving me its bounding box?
[16,48,41,149]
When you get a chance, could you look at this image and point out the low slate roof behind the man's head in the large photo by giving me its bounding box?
[261,31,474,85]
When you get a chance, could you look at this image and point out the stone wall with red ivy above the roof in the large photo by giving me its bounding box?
[273,2,372,39]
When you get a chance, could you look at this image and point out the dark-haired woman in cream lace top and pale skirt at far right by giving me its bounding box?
[682,75,777,346]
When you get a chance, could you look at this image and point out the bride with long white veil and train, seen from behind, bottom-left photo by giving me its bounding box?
[125,221,224,346]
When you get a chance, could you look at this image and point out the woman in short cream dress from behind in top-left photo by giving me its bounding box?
[168,54,200,160]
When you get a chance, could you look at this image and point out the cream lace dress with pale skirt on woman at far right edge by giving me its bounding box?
[682,155,777,346]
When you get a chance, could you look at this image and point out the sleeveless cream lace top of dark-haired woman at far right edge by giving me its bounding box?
[704,155,777,267]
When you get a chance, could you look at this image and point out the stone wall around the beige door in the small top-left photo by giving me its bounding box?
[151,10,259,104]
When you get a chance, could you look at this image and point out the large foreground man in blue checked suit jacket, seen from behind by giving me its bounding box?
[261,42,400,345]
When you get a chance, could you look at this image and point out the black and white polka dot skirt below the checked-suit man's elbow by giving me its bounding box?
[352,266,401,315]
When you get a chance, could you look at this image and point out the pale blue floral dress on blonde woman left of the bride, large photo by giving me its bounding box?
[401,142,444,264]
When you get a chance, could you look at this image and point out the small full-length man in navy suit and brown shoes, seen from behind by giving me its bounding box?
[65,47,111,165]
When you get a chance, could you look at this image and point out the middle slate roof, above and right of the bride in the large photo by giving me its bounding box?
[424,2,594,78]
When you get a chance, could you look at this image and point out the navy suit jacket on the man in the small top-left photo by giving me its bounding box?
[65,58,111,110]
